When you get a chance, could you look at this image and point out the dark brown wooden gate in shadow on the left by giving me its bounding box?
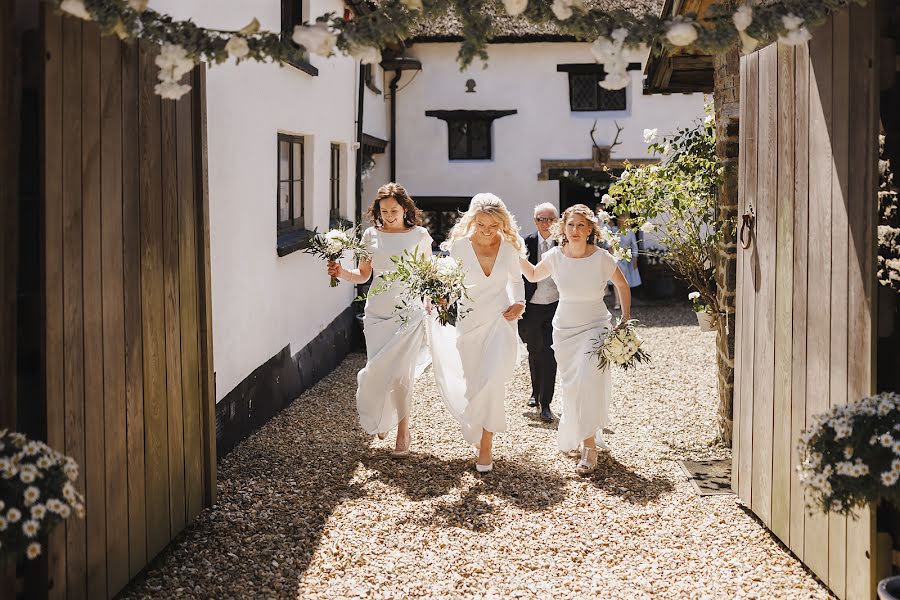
[41,9,215,598]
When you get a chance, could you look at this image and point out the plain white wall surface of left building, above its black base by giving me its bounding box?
[150,0,358,401]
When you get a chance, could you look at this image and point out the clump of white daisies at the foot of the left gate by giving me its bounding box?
[0,430,84,560]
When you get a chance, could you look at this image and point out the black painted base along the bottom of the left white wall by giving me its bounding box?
[216,306,360,459]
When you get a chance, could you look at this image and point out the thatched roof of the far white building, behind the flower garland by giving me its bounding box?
[412,0,664,42]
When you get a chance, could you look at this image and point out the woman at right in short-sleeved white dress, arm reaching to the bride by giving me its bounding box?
[519,204,631,475]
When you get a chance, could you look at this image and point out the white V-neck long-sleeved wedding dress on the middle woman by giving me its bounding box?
[429,238,525,445]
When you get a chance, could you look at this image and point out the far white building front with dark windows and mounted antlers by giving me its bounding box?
[367,39,704,244]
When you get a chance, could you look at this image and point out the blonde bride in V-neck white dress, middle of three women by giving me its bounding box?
[432,194,525,473]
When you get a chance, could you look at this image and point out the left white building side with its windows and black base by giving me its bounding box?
[152,0,371,454]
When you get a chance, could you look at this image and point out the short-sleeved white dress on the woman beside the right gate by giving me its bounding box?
[541,248,618,451]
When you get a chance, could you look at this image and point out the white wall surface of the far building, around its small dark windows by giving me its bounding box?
[388,43,703,232]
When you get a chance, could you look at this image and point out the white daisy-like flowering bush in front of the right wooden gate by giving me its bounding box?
[797,392,900,515]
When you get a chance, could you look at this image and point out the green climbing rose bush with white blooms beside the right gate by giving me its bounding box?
[607,106,734,324]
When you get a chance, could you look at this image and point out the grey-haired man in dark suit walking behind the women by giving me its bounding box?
[519,202,559,423]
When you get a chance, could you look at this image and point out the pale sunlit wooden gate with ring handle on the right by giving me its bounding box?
[733,3,878,599]
